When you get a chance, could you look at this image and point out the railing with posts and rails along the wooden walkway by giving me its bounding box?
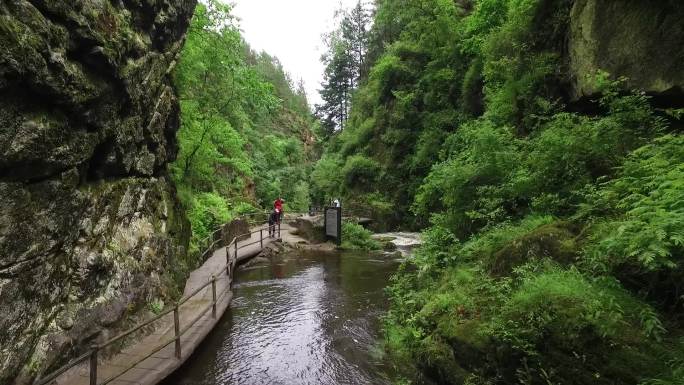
[34,220,280,385]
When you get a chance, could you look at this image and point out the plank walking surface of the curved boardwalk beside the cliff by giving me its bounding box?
[52,226,288,385]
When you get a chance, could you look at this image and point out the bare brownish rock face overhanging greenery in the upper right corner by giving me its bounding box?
[569,0,684,98]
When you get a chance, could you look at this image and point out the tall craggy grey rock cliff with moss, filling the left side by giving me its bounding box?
[0,0,195,384]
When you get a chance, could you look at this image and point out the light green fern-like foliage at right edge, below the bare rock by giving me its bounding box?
[588,135,684,270]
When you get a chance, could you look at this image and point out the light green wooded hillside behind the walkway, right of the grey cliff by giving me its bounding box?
[170,1,316,251]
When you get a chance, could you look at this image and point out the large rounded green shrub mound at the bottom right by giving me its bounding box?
[483,264,672,384]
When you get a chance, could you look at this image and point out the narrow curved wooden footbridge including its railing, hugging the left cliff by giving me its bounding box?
[34,218,289,385]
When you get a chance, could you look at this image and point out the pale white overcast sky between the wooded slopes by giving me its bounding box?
[226,0,358,106]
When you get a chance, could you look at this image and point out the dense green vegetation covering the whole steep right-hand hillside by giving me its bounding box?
[312,0,684,384]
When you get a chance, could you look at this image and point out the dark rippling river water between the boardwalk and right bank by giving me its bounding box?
[166,246,416,385]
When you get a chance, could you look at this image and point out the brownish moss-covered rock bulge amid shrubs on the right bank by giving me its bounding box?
[488,222,578,277]
